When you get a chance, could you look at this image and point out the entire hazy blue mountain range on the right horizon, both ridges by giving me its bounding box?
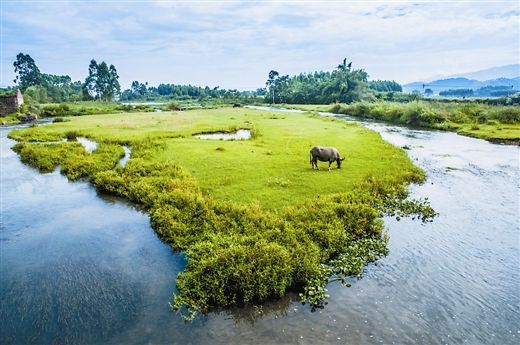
[403,64,520,94]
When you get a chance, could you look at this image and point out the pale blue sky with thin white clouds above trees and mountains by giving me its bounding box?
[0,0,520,89]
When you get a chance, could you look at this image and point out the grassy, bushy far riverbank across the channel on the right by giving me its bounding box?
[282,101,520,145]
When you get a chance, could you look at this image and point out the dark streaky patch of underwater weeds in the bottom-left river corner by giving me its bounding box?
[0,257,141,344]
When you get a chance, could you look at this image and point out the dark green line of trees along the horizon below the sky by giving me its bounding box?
[13,53,402,104]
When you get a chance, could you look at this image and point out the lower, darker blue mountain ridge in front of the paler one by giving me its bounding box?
[403,77,520,94]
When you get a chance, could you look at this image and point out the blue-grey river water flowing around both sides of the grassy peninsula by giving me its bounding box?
[0,111,520,345]
